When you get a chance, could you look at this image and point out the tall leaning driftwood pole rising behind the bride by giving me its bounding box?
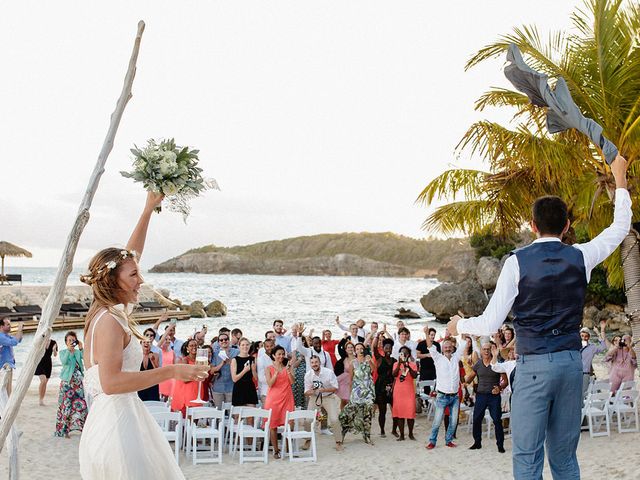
[0,21,144,451]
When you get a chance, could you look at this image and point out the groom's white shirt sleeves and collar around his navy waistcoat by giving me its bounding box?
[458,188,631,335]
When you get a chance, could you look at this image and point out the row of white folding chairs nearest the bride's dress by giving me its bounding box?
[144,402,317,465]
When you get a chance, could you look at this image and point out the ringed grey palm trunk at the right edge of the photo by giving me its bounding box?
[620,229,640,355]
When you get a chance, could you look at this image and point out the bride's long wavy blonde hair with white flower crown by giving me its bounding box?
[80,247,143,339]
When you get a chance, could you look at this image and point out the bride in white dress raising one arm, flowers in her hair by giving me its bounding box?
[79,193,207,480]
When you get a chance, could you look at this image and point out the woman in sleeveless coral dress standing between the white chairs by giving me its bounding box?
[264,345,295,458]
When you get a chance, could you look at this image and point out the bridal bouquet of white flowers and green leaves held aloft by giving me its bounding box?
[120,139,220,222]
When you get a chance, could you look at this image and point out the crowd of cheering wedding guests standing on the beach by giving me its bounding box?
[0,317,638,450]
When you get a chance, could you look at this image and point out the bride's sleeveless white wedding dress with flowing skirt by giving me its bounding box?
[79,310,184,480]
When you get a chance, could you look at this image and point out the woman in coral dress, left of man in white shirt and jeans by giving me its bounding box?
[391,345,418,441]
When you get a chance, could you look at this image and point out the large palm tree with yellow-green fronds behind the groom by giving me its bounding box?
[417,0,640,344]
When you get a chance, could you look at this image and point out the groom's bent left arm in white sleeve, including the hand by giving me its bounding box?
[447,255,520,335]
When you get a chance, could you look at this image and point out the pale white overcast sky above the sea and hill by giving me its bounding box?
[0,0,582,267]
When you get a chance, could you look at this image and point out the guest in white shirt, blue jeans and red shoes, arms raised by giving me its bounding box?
[426,336,464,450]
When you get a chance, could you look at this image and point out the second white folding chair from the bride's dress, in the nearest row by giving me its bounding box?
[190,407,224,465]
